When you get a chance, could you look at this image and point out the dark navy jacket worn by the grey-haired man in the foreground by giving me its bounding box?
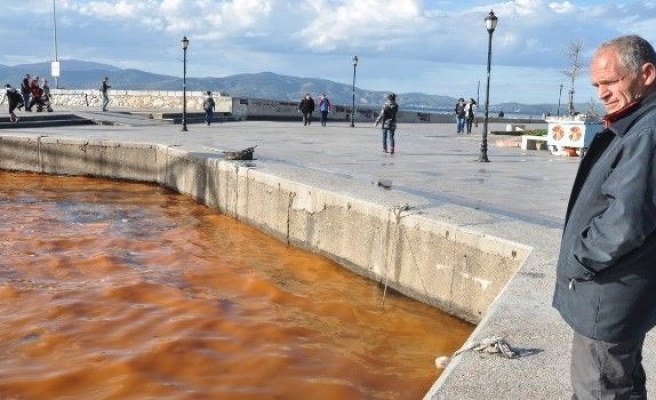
[553,95,656,342]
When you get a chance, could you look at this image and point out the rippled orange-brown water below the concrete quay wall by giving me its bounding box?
[0,172,472,400]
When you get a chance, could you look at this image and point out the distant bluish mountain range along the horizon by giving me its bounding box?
[0,60,588,116]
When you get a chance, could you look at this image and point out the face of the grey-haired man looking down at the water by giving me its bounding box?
[590,48,645,114]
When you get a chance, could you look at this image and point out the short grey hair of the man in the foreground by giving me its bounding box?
[597,35,656,77]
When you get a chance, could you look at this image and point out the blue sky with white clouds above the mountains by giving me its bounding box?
[0,0,656,104]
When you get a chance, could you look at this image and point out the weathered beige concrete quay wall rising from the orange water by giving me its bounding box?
[0,136,530,323]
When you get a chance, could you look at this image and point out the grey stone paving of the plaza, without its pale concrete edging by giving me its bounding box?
[18,109,579,227]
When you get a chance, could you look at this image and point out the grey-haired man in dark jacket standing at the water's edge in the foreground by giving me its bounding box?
[553,35,656,400]
